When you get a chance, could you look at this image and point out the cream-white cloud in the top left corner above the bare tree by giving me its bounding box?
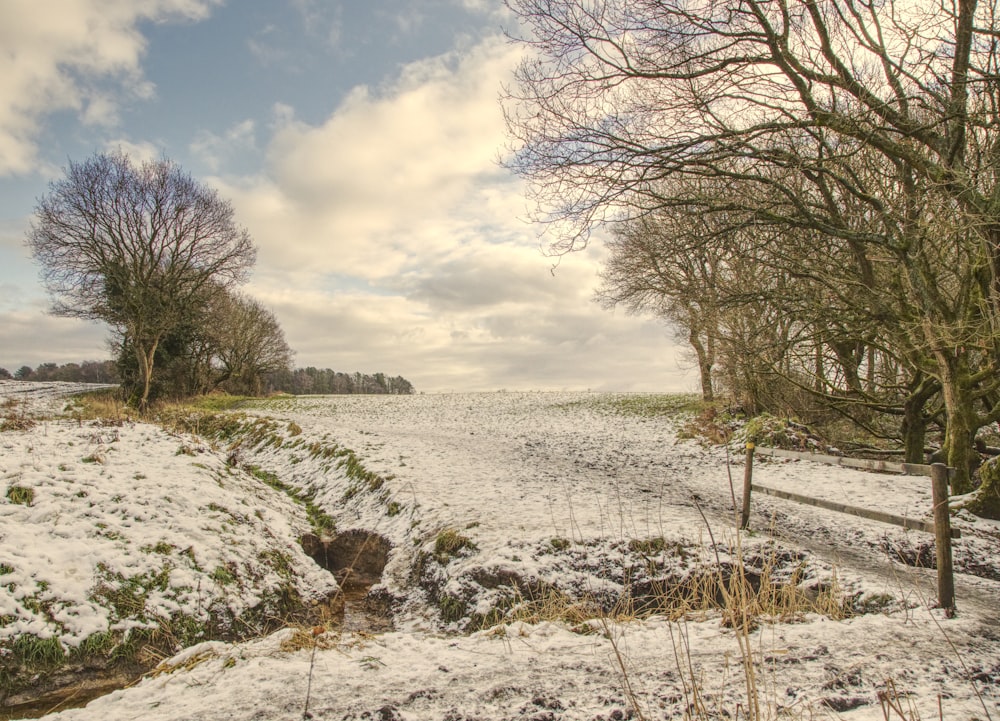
[0,0,219,175]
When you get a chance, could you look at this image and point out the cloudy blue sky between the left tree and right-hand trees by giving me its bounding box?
[0,0,696,392]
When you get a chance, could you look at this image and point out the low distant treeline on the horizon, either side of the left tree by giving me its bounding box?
[0,361,415,395]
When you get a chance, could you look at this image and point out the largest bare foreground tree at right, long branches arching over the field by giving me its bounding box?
[505,0,1000,492]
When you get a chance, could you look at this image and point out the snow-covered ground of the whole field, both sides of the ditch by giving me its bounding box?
[0,382,1000,721]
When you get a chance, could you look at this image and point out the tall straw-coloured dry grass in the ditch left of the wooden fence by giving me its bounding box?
[500,534,852,721]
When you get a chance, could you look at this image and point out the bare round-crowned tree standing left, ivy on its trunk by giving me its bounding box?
[27,152,256,408]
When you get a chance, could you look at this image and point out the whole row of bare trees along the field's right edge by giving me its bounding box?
[504,0,1000,509]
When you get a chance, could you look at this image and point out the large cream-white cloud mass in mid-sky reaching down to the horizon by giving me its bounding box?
[207,33,689,390]
